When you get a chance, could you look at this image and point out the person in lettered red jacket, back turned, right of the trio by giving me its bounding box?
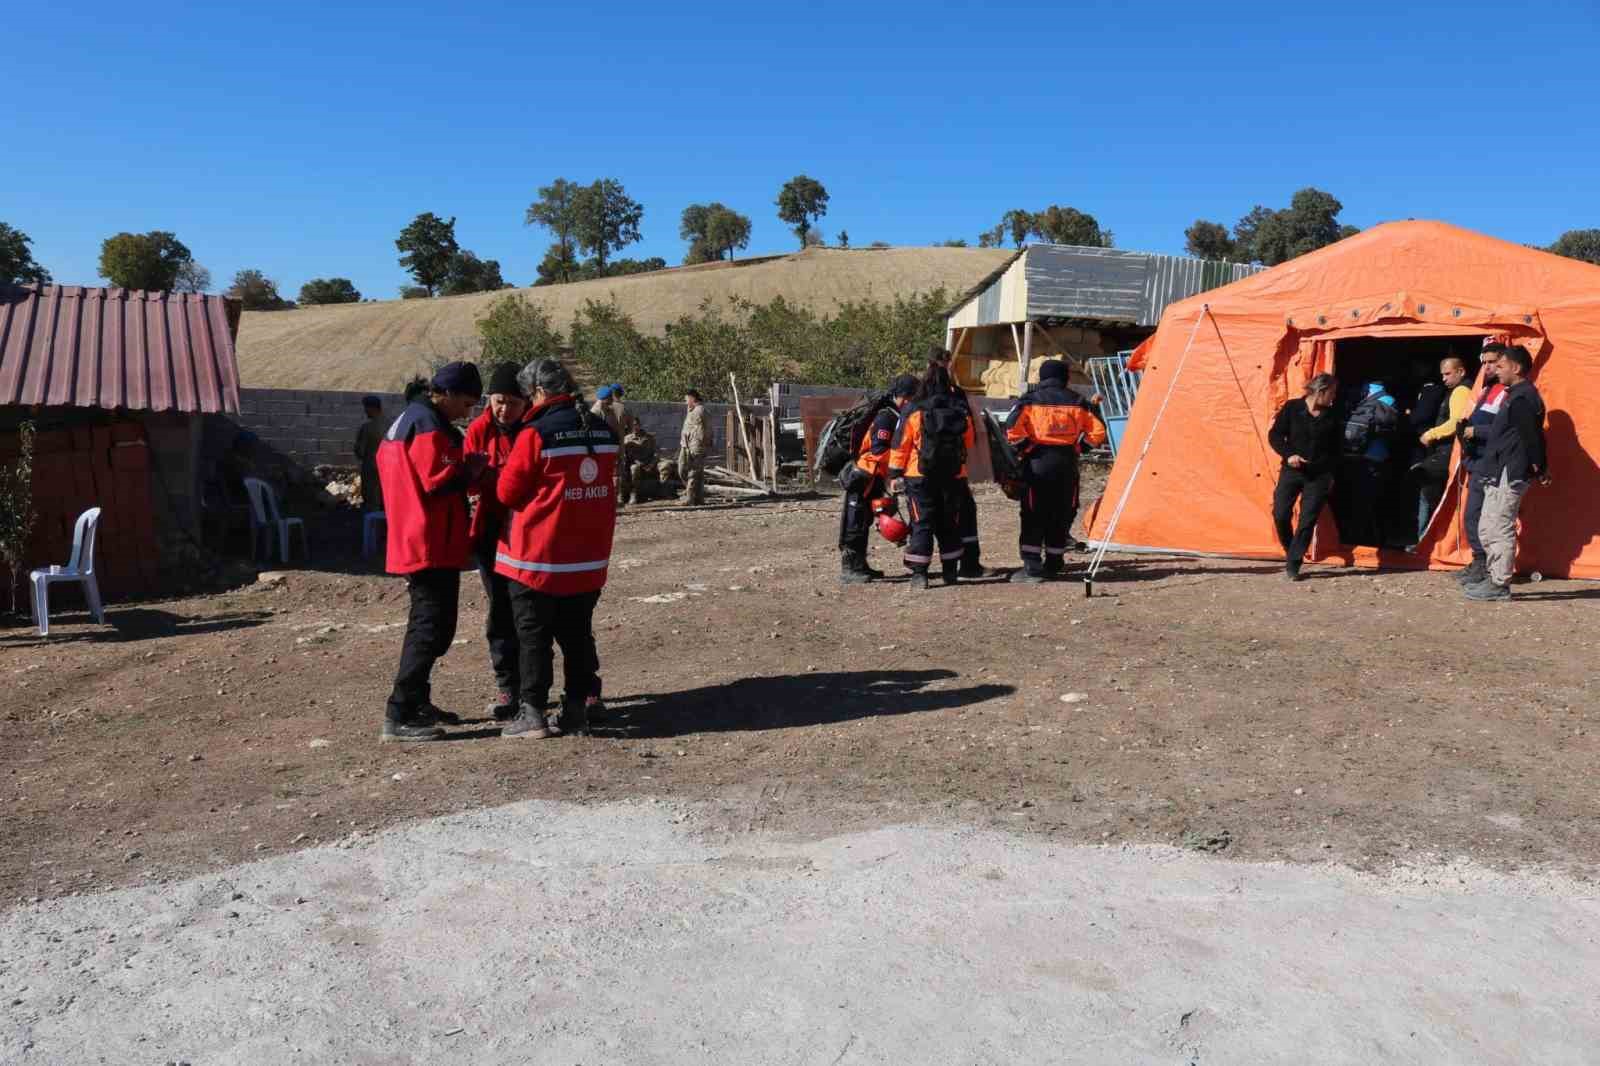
[494,359,621,739]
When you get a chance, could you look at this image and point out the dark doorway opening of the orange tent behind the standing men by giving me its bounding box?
[1330,335,1480,551]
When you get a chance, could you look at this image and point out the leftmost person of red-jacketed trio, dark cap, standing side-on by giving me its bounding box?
[378,363,483,741]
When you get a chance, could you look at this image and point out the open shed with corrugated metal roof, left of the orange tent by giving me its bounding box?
[946,245,1262,395]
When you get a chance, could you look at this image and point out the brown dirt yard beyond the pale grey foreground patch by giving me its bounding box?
[0,476,1600,906]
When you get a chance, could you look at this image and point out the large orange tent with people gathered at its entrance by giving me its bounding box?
[1088,222,1600,578]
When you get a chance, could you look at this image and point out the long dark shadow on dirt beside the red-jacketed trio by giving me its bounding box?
[594,669,1016,738]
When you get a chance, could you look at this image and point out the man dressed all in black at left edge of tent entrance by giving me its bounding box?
[1267,375,1341,581]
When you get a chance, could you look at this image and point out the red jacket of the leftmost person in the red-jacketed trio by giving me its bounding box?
[378,400,470,573]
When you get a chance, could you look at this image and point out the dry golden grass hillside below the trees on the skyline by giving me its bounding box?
[238,248,1013,389]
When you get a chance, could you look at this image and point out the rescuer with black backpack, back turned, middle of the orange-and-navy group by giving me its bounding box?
[888,362,973,589]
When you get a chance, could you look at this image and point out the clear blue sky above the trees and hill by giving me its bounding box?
[0,0,1600,299]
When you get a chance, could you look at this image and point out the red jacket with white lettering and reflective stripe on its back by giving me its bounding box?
[494,395,618,595]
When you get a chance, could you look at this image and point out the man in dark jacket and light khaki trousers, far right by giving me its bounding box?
[1467,344,1550,600]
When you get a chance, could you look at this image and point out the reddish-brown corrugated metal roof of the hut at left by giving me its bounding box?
[0,285,238,413]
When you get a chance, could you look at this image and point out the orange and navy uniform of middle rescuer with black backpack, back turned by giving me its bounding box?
[888,395,974,583]
